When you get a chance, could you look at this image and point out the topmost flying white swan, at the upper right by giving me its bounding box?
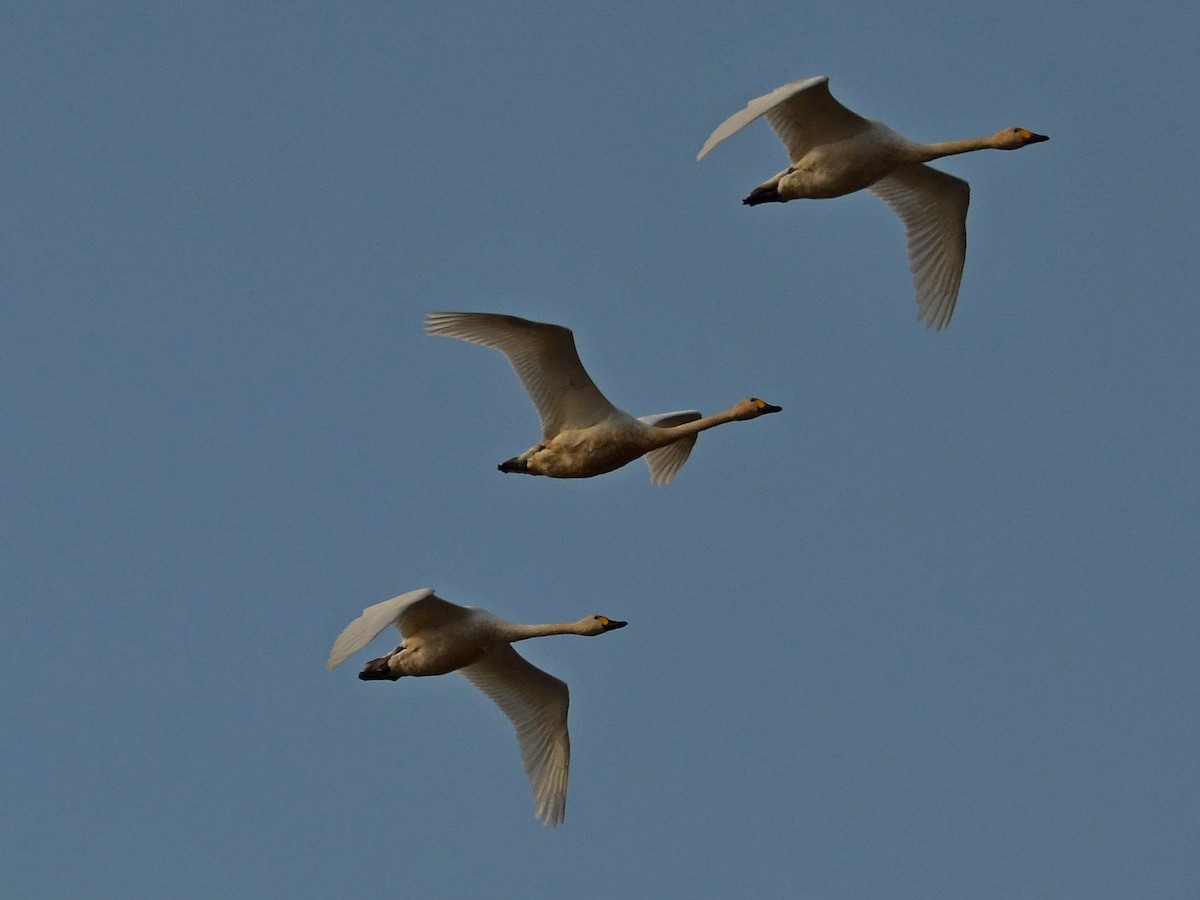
[696,76,1050,330]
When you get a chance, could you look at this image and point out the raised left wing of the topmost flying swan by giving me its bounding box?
[696,76,871,162]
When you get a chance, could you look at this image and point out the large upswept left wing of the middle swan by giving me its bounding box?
[425,312,622,439]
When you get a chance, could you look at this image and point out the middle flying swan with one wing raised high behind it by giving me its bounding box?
[425,312,780,485]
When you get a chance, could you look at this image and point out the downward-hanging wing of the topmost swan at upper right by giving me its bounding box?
[868,166,971,331]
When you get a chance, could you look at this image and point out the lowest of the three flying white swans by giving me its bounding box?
[325,588,628,826]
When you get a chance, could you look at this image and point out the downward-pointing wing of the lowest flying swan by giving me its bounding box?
[458,643,571,826]
